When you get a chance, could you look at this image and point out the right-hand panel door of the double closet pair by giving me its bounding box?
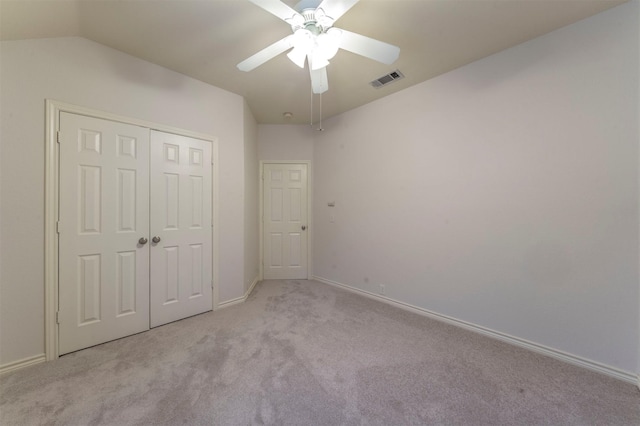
[150,130,213,327]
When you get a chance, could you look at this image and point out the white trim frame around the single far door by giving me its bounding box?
[258,160,315,281]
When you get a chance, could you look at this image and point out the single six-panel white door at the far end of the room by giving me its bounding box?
[262,164,308,279]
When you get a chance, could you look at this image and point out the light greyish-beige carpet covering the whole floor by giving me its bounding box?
[0,281,640,425]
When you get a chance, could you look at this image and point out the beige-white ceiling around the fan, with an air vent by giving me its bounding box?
[0,0,627,124]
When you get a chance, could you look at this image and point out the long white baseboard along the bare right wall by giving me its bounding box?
[313,276,640,388]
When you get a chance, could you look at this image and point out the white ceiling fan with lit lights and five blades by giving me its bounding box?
[237,0,400,93]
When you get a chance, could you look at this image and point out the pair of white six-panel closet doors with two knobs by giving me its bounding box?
[58,113,213,354]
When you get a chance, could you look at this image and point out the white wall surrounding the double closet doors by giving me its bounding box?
[0,38,245,365]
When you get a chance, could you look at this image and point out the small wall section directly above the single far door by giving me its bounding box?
[258,124,318,161]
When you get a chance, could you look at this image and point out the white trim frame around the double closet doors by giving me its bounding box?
[44,99,220,361]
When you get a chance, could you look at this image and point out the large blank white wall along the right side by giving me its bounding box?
[313,2,639,372]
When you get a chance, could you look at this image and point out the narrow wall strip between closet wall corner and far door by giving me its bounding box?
[243,102,260,294]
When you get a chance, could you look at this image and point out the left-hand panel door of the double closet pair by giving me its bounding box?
[58,113,149,354]
